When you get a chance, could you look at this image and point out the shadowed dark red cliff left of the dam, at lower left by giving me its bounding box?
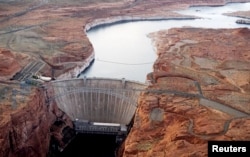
[0,86,73,157]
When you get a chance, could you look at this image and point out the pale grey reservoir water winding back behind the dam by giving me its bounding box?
[80,3,250,82]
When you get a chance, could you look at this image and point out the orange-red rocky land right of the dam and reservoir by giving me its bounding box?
[123,28,250,157]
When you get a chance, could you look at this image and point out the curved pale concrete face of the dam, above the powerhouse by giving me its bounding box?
[51,77,146,125]
